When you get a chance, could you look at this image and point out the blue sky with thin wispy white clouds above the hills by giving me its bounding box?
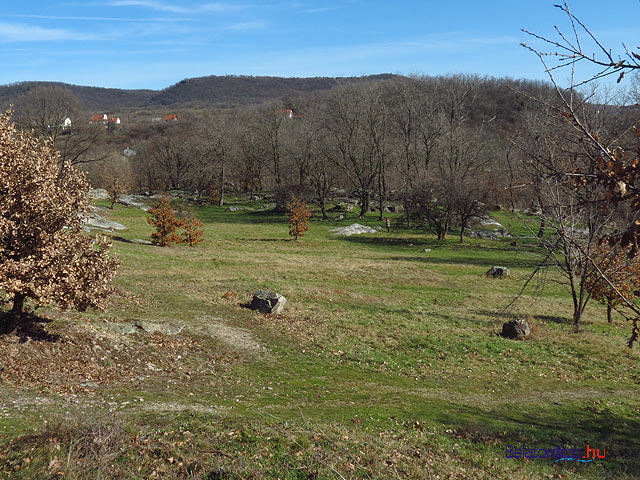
[0,0,640,89]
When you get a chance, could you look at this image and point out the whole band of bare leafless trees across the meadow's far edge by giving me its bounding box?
[10,75,633,246]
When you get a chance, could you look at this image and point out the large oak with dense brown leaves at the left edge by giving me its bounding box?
[0,111,118,332]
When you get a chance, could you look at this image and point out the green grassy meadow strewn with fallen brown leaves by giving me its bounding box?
[0,197,640,480]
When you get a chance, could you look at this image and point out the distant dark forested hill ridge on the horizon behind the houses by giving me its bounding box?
[0,74,396,111]
